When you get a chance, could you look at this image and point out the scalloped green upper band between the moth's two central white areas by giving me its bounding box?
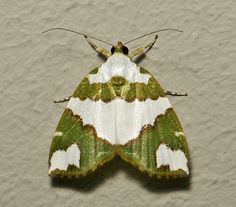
[73,68,165,102]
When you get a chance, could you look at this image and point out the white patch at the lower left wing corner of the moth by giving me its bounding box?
[48,143,80,174]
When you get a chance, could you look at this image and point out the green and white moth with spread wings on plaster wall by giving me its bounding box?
[45,28,190,178]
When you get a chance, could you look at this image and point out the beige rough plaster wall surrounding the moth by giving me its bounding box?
[0,0,236,207]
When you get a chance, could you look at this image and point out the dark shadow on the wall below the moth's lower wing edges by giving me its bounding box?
[51,157,190,193]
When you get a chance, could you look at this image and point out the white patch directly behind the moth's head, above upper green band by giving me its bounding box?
[88,53,151,84]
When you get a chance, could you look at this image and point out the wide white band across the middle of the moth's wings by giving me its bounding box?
[67,97,171,144]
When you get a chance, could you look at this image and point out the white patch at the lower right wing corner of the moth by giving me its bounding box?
[156,144,189,174]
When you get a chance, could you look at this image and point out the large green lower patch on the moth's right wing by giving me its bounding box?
[118,108,189,178]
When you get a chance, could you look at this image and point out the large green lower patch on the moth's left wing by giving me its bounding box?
[49,109,115,177]
